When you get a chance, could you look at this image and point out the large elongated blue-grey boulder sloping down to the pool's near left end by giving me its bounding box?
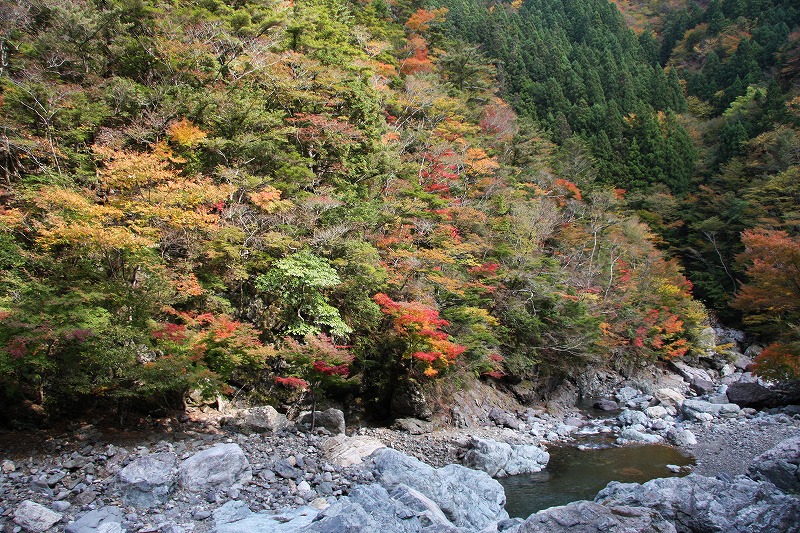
[370,448,508,531]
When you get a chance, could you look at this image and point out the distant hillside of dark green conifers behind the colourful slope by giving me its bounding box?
[444,0,800,377]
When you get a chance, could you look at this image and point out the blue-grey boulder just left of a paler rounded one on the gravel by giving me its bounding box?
[117,452,178,508]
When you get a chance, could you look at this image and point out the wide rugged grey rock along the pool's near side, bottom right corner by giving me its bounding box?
[594,474,800,533]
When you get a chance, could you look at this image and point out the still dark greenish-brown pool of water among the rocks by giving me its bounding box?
[498,444,694,518]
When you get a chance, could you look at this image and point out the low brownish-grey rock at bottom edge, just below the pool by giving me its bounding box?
[517,501,675,533]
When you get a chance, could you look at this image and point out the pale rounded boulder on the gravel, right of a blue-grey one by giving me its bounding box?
[179,443,253,492]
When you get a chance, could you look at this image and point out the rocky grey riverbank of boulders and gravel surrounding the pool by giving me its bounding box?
[0,324,800,533]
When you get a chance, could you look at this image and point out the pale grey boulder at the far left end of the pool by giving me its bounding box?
[463,437,550,477]
